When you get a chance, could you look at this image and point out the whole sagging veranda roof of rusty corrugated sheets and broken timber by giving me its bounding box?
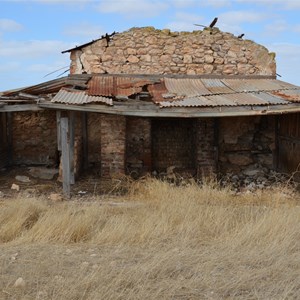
[0,74,300,117]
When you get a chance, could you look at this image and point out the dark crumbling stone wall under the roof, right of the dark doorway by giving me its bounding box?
[219,116,275,173]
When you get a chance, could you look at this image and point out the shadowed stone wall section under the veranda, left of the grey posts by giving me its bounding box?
[12,111,58,165]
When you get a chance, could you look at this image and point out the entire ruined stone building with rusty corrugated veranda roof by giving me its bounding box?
[0,27,300,191]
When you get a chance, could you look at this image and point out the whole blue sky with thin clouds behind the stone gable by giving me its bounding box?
[0,0,300,91]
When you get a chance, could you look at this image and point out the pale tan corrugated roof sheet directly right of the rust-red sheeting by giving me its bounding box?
[164,78,212,97]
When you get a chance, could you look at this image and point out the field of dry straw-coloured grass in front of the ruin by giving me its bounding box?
[0,180,300,300]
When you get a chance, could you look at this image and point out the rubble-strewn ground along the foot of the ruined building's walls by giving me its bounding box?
[0,164,300,201]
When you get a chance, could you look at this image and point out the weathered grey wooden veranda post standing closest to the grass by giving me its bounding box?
[60,118,71,198]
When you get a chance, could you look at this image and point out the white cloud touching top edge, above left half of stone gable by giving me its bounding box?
[97,0,169,18]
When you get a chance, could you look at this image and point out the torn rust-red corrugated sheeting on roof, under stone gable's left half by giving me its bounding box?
[88,76,153,96]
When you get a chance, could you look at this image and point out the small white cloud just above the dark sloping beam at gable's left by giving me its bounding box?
[63,22,104,39]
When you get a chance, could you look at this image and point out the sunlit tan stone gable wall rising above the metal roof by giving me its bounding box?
[70,27,276,75]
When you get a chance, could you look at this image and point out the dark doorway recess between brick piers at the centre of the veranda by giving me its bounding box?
[152,119,196,173]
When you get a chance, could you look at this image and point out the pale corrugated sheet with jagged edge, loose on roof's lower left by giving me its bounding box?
[51,89,113,105]
